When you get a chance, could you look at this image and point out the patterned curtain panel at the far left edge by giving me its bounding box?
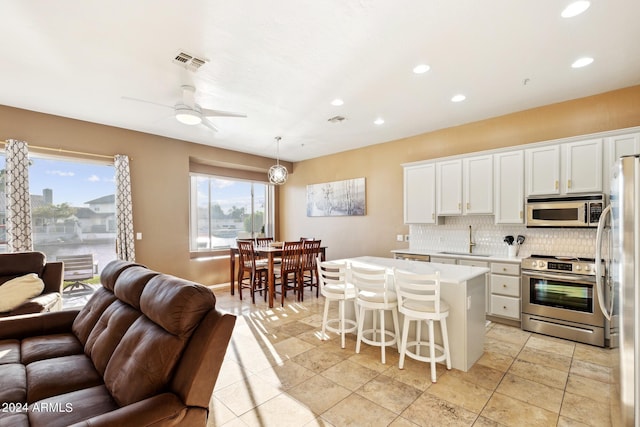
[5,139,33,252]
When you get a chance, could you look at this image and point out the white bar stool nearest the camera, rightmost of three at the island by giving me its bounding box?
[393,269,451,383]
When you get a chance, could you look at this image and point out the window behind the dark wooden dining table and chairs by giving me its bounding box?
[190,174,273,252]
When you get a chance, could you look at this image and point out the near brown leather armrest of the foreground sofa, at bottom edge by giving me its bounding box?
[67,393,207,427]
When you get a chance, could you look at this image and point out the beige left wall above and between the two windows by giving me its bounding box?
[0,106,291,284]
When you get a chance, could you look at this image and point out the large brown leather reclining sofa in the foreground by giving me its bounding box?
[0,261,236,427]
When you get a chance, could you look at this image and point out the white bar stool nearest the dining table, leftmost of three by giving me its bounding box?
[316,255,358,348]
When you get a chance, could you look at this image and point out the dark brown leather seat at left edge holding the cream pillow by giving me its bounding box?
[0,252,63,317]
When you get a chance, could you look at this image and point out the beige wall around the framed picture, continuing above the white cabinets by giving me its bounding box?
[280,86,640,259]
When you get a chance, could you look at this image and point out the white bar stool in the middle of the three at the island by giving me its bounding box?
[350,264,400,364]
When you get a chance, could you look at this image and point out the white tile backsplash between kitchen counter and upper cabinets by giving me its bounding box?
[409,215,596,258]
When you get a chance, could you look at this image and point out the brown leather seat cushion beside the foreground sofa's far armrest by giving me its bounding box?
[20,332,83,365]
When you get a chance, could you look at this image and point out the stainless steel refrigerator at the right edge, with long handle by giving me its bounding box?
[596,155,640,426]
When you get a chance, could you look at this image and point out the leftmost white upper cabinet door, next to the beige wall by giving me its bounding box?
[404,163,436,224]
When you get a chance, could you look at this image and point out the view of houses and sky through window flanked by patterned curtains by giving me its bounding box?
[0,155,116,272]
